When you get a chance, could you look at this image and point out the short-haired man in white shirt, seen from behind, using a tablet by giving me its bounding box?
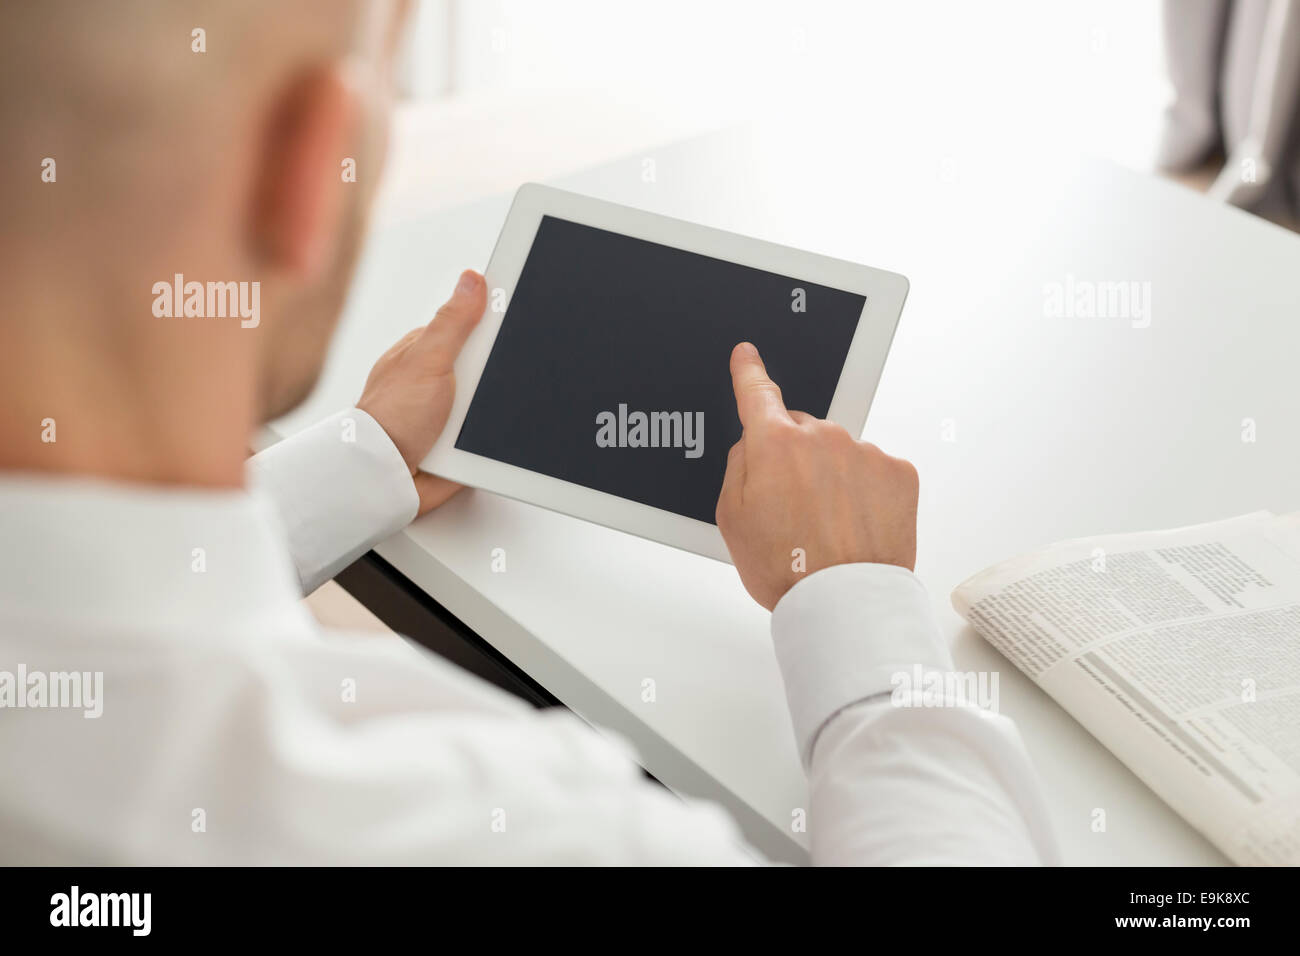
[0,0,1056,864]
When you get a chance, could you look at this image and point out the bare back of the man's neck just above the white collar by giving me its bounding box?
[0,293,256,488]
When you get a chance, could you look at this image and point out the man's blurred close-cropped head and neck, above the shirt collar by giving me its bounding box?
[0,0,404,476]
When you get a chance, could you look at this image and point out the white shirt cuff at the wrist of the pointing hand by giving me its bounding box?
[772,564,952,767]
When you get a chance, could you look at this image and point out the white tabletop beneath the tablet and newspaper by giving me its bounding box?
[273,119,1300,865]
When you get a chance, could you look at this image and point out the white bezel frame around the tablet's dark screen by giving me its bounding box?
[421,183,907,561]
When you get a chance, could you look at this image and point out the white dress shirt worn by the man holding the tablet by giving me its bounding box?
[0,408,1056,865]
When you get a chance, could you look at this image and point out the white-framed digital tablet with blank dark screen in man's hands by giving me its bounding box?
[421,183,907,561]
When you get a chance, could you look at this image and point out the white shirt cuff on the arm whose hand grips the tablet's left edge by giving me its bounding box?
[248,408,420,594]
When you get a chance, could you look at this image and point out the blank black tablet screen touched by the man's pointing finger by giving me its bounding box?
[456,216,866,524]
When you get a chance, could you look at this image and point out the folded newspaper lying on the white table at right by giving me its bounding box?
[953,511,1300,865]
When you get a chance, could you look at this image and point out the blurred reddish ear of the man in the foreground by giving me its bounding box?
[254,62,360,280]
